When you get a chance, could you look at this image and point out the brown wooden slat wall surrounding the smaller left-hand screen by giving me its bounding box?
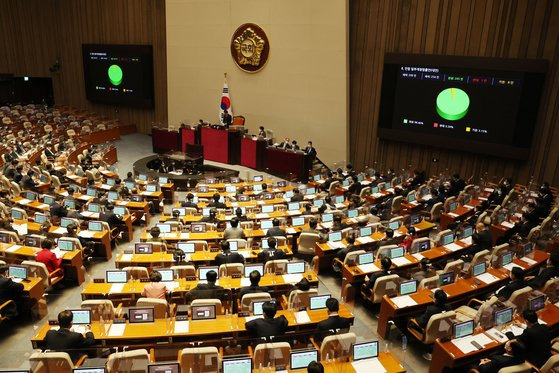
[0,0,167,133]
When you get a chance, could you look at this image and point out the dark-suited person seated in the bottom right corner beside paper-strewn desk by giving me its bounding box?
[507,309,551,368]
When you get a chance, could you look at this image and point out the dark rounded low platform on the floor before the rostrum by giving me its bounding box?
[132,155,239,190]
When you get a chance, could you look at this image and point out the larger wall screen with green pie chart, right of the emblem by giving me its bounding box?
[379,54,547,159]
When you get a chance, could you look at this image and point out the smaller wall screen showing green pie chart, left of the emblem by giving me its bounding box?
[82,44,153,107]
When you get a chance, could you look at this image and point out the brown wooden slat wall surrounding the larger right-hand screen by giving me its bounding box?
[349,0,559,186]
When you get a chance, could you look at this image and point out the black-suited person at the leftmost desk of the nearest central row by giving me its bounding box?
[45,310,95,362]
